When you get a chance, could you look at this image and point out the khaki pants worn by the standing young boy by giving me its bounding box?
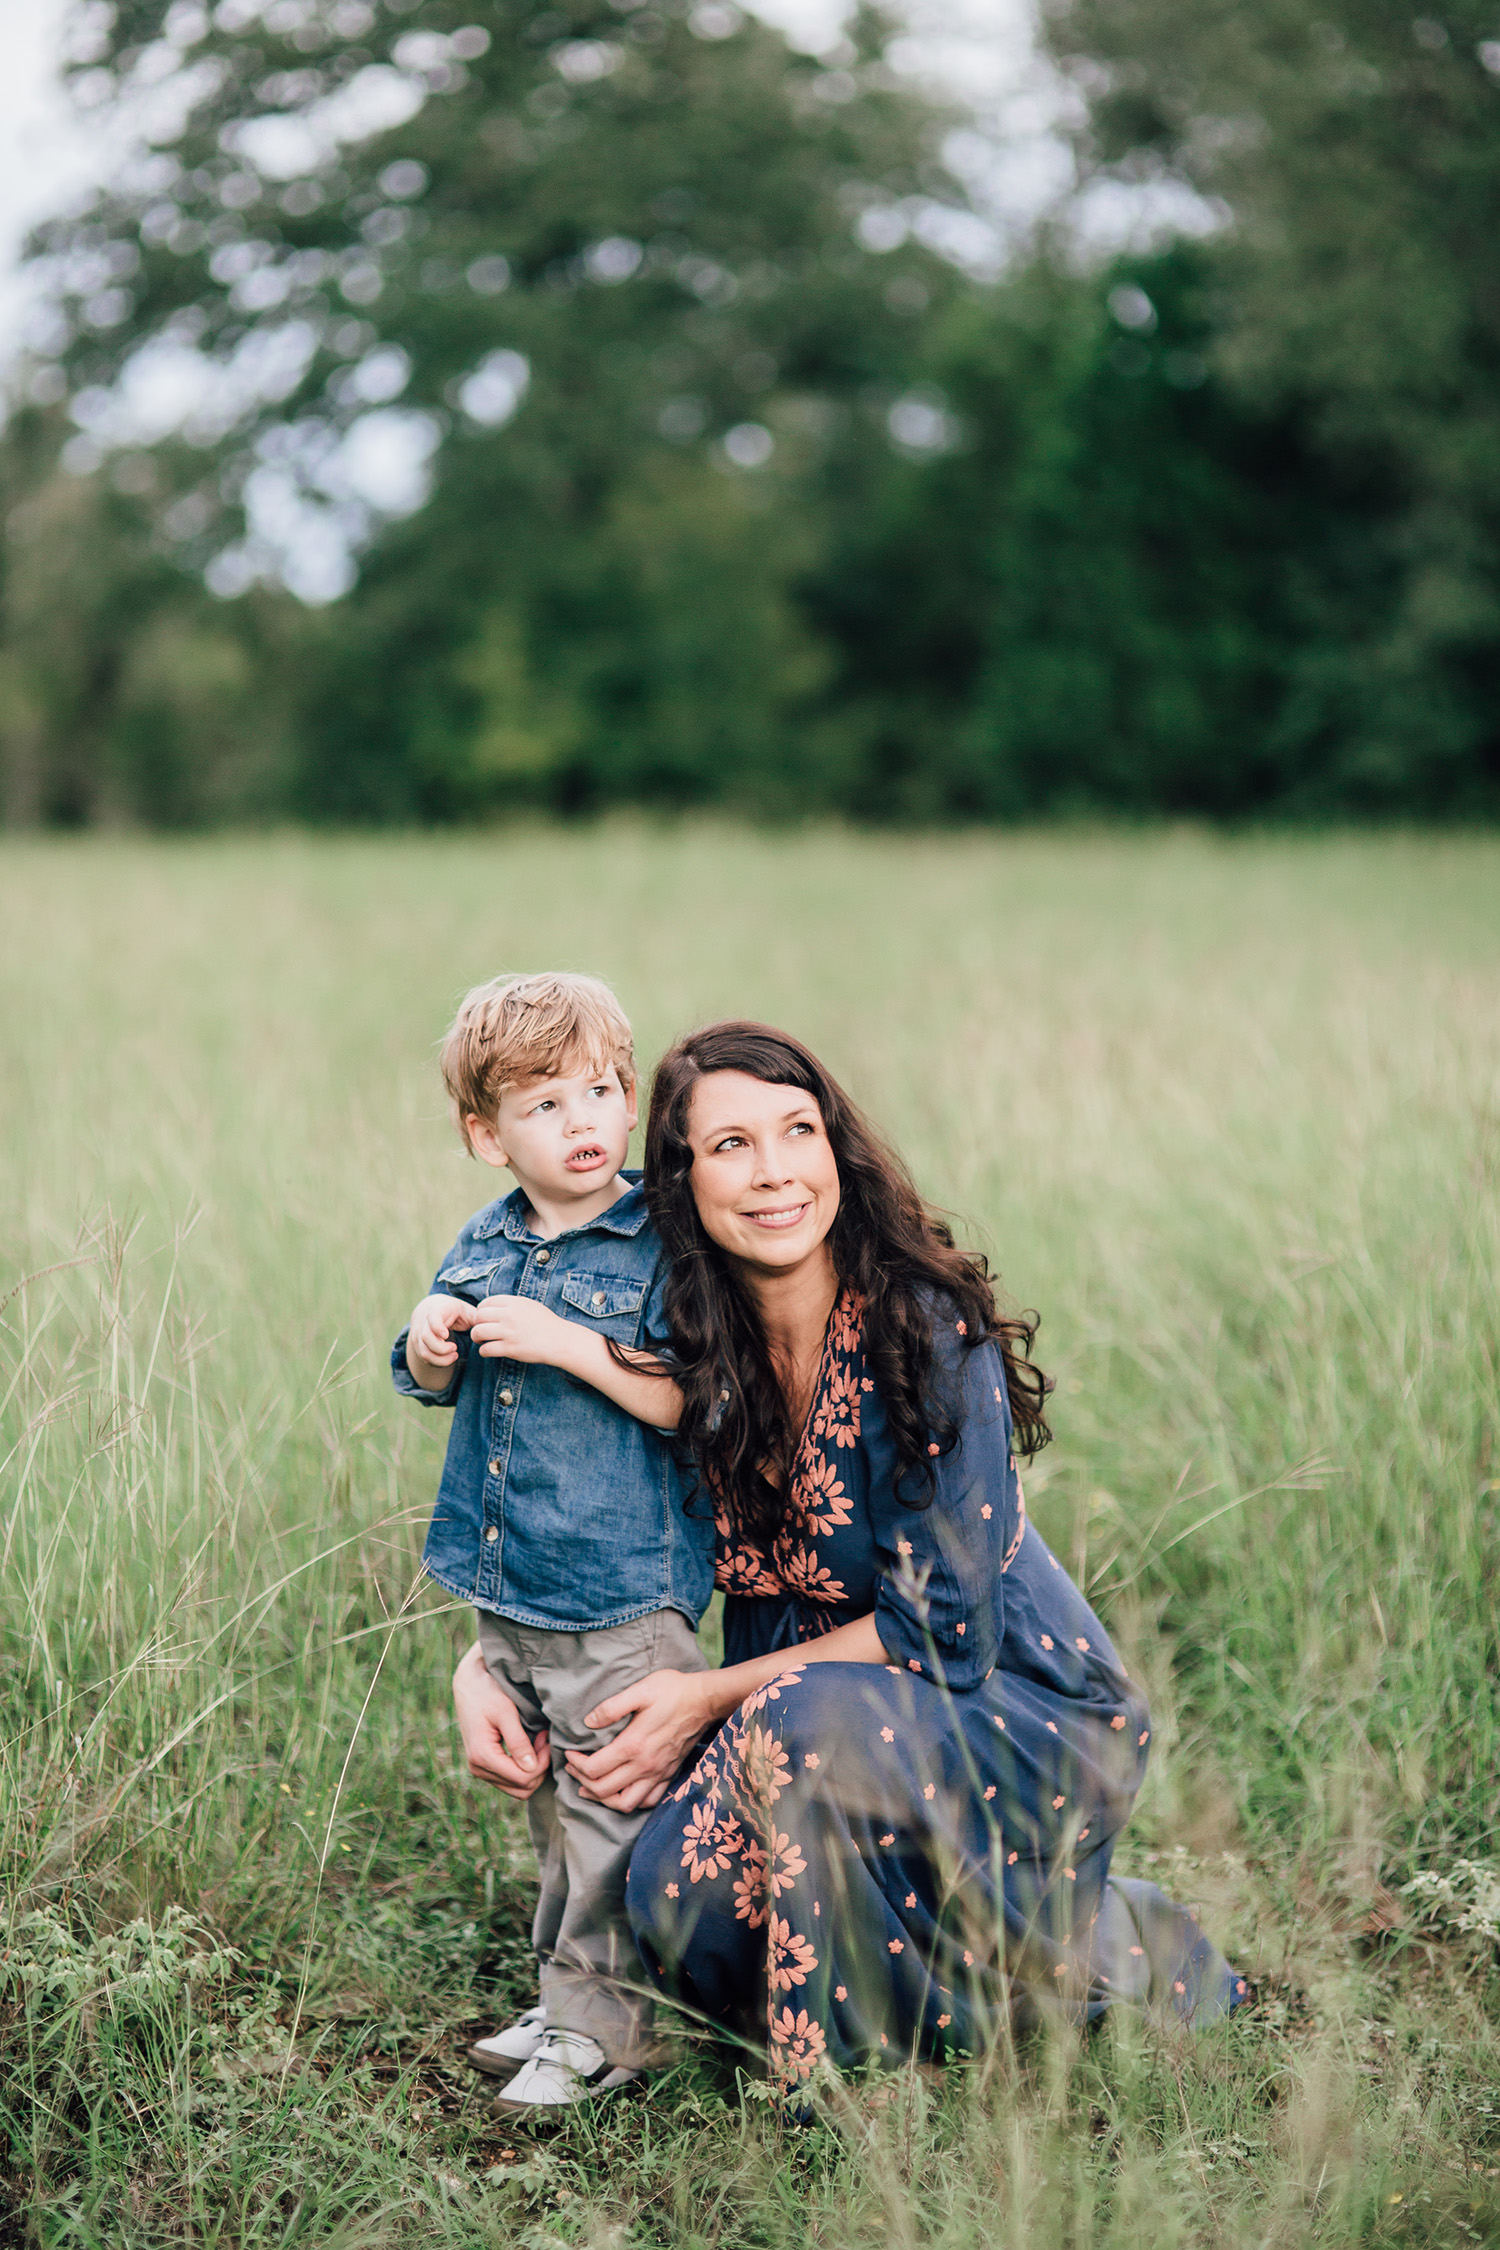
[479,1609,708,2068]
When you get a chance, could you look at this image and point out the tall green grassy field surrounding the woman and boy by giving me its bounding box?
[0,826,1500,2250]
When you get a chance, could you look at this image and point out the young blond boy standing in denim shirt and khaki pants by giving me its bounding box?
[391,977,713,2108]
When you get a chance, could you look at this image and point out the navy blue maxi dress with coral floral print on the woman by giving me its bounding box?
[627,1294,1246,2084]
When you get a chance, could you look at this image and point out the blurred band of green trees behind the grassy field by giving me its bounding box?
[0,0,1500,824]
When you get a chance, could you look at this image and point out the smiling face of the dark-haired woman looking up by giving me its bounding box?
[688,1071,839,1274]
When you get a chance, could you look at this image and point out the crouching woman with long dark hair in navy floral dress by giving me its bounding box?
[461,1024,1246,2081]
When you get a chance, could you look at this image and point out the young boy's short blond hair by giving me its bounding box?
[439,972,636,1148]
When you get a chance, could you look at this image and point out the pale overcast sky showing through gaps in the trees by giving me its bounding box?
[0,0,1187,601]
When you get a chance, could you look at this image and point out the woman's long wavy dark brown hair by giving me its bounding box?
[645,1022,1052,1544]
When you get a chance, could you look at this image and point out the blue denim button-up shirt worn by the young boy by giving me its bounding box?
[391,1172,713,1631]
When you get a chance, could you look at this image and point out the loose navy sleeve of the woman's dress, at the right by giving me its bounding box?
[870,1314,1019,1694]
